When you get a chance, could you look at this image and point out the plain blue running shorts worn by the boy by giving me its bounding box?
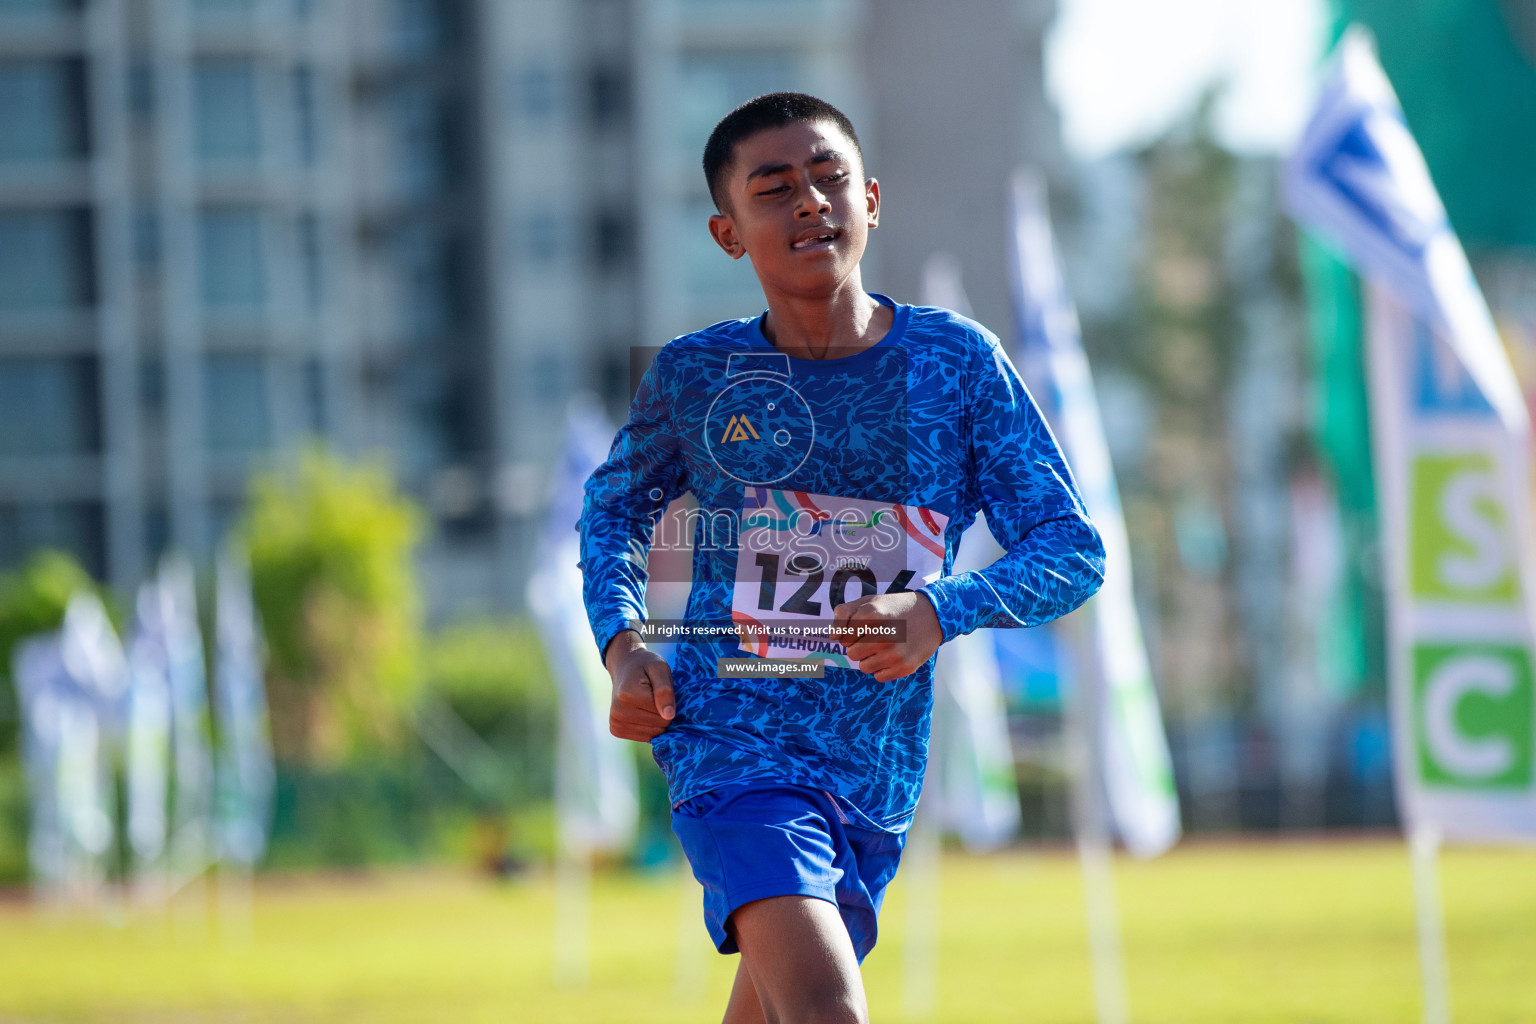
[673,783,906,963]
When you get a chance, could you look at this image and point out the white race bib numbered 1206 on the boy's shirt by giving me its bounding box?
[731,487,949,668]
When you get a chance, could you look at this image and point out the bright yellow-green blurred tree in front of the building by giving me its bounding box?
[240,445,421,763]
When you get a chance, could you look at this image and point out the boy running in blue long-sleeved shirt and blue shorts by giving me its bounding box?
[579,92,1103,1024]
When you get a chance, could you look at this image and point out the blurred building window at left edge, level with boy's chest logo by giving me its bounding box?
[0,356,101,459]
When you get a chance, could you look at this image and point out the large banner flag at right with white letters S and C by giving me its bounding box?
[1284,29,1536,840]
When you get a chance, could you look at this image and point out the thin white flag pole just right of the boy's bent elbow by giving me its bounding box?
[1066,611,1130,1024]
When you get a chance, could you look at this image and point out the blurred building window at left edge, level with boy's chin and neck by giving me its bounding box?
[0,210,92,312]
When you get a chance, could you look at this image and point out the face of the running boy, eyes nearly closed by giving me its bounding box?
[710,121,880,298]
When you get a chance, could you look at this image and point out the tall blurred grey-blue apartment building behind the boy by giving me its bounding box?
[0,0,1055,619]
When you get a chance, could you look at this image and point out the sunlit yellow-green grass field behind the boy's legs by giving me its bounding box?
[0,840,1536,1024]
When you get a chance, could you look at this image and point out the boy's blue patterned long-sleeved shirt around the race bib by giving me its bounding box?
[578,295,1104,832]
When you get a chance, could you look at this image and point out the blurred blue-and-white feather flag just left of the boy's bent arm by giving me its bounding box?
[528,398,639,854]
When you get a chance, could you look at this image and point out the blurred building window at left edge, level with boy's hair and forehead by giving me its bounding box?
[0,60,86,163]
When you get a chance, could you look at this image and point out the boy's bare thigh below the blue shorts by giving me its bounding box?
[730,897,869,1022]
